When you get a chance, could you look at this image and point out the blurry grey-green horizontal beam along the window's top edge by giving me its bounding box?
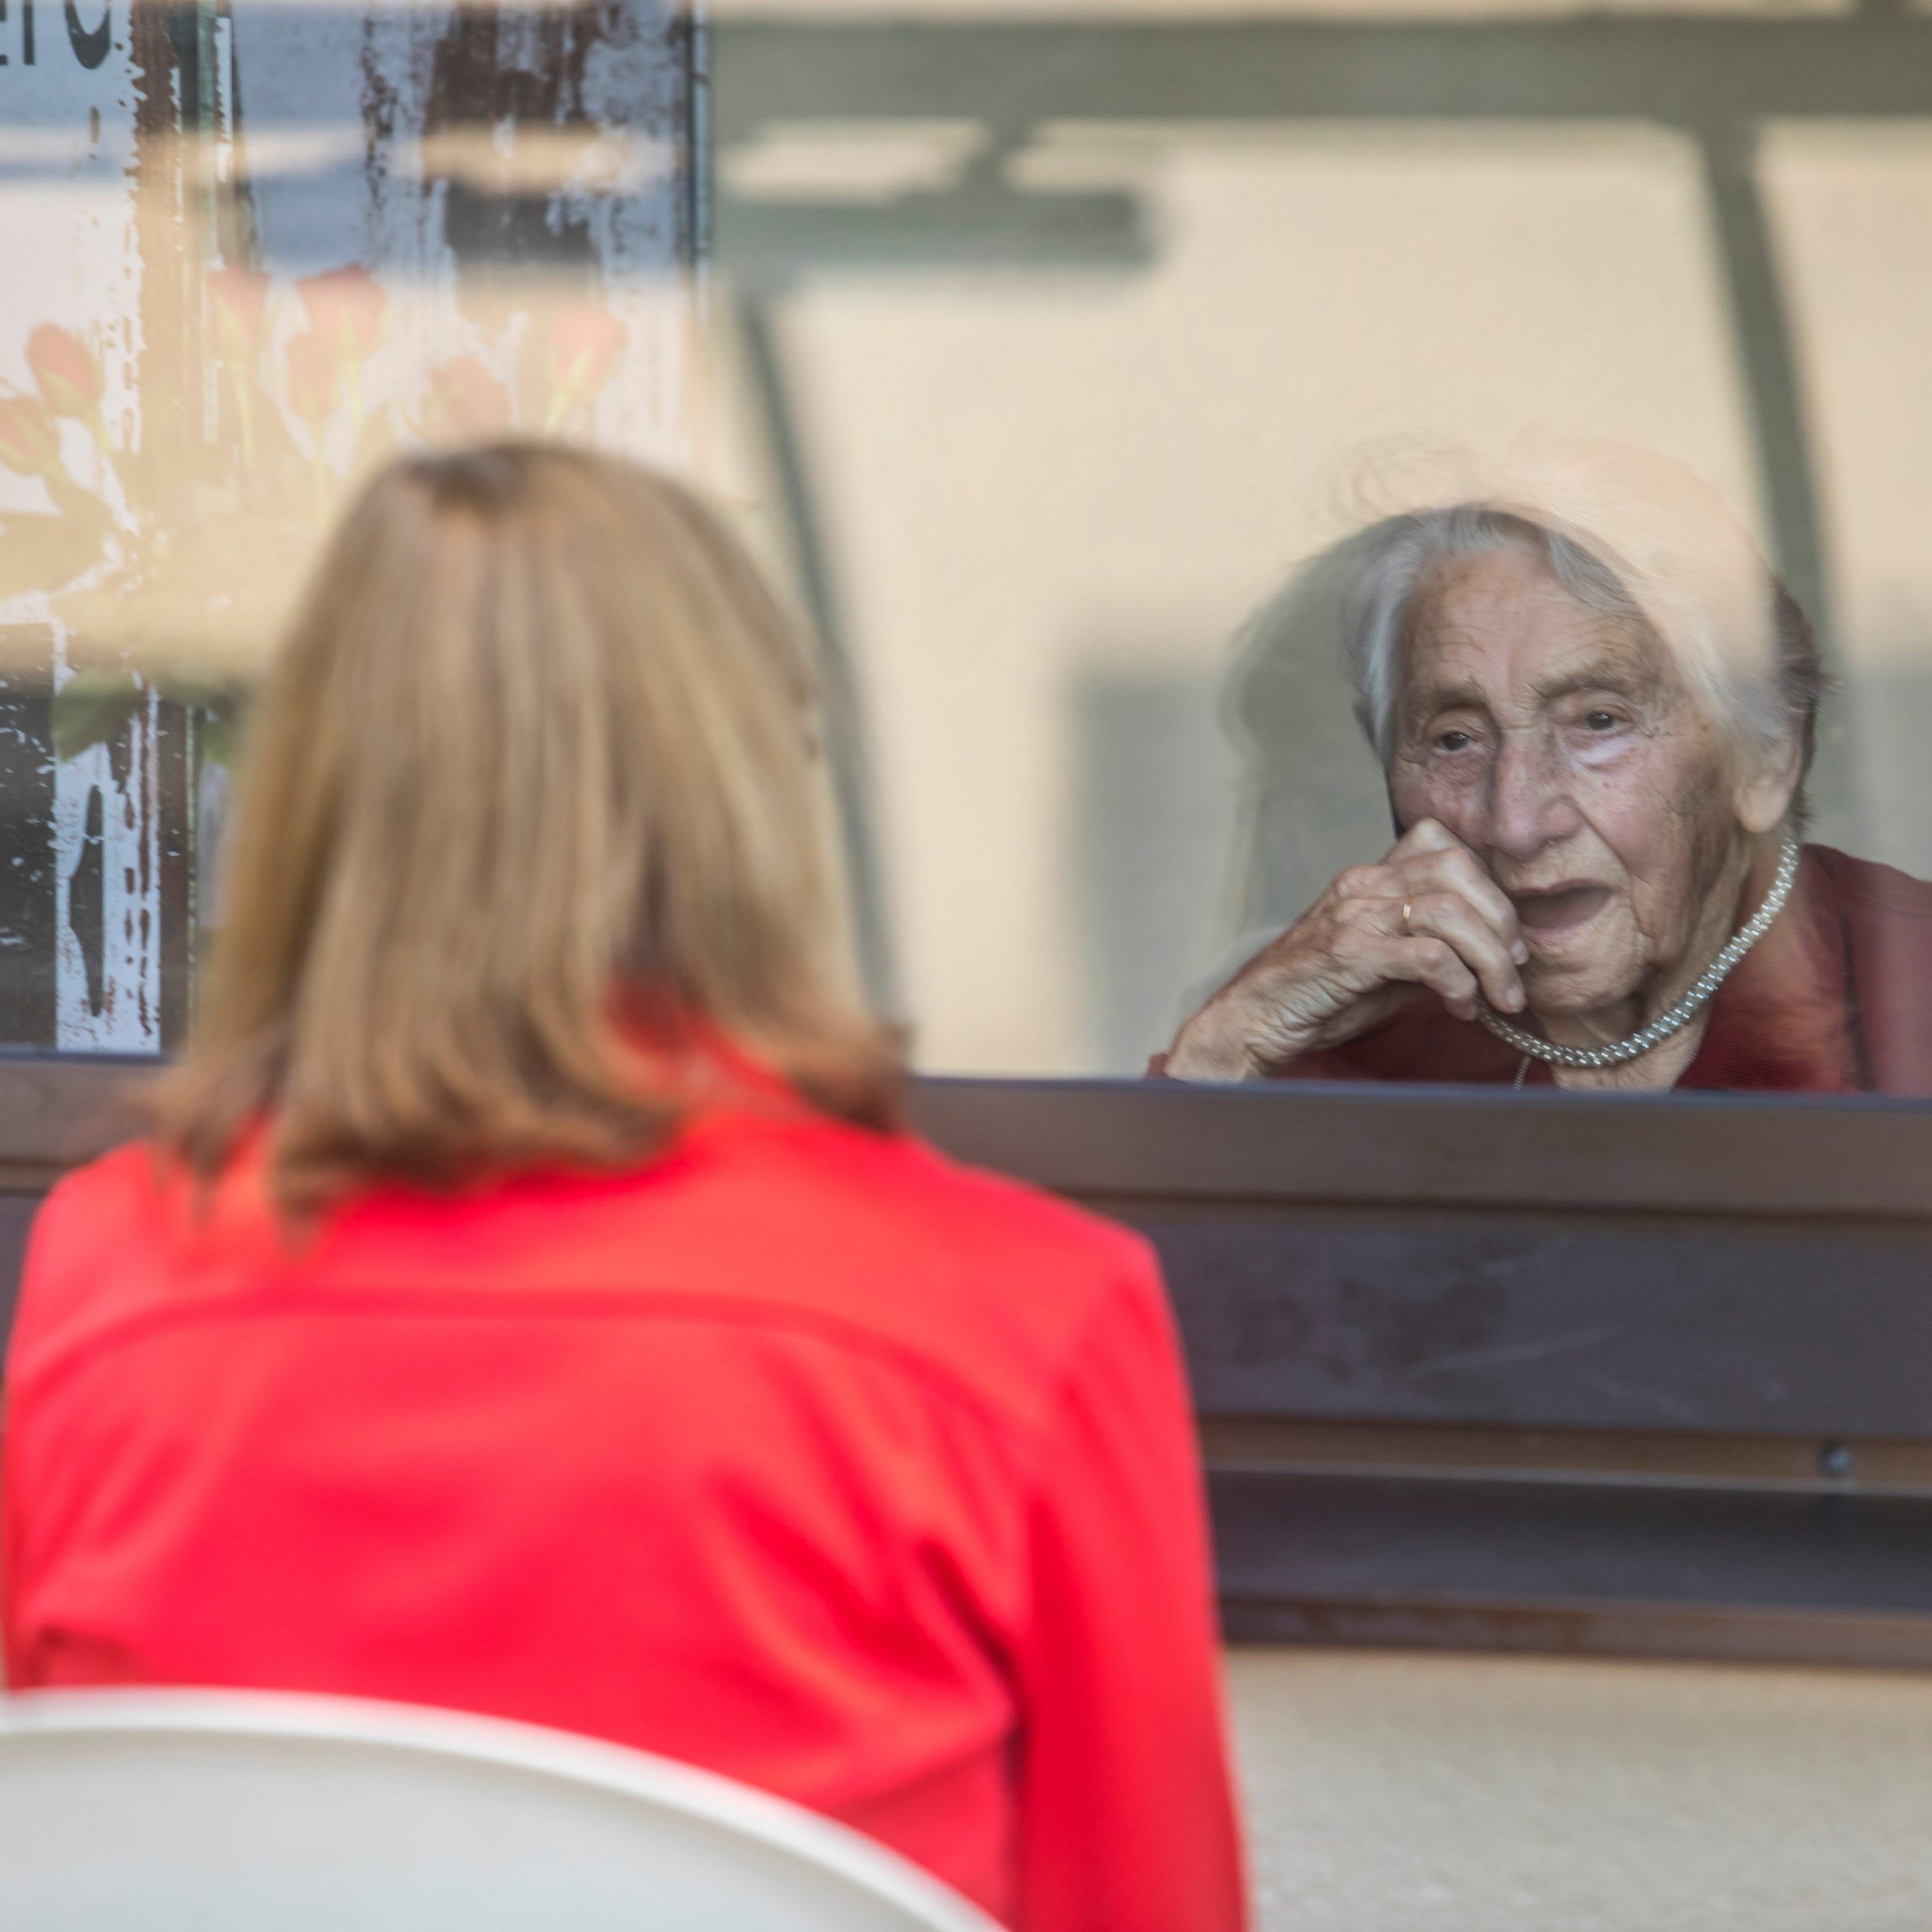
[713,13,1932,143]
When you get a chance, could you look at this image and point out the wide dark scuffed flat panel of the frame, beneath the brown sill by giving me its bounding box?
[1123,1208,1932,1440]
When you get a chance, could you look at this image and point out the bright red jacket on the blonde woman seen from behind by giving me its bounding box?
[6,1088,1242,1932]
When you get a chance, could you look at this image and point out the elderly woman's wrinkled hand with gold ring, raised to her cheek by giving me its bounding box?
[1167,819,1530,1080]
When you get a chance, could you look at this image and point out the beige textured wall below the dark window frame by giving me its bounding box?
[1229,1650,1932,1932]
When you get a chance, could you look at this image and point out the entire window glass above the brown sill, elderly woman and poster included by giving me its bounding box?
[0,0,1932,1092]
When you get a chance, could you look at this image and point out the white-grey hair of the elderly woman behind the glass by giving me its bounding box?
[1343,502,1826,811]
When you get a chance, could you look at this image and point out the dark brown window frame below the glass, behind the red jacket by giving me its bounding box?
[0,1053,1932,1665]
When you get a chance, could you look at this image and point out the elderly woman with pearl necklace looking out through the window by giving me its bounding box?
[1155,463,1932,1094]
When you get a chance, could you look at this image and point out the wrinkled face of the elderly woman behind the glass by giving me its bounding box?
[1391,547,1749,1012]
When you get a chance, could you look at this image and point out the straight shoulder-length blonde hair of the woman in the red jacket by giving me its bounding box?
[154,442,898,1210]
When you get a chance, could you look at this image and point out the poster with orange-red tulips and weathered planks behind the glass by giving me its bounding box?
[0,0,693,1053]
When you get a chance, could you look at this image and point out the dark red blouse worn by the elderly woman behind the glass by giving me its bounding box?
[1155,846,1932,1095]
